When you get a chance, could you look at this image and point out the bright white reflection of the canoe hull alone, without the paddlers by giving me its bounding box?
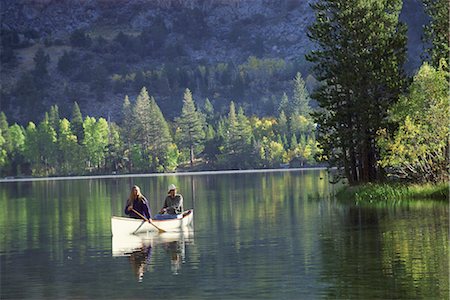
[112,226,194,256]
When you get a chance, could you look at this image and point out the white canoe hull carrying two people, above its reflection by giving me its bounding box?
[111,209,194,235]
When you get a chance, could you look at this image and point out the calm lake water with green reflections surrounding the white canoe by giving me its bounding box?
[0,170,449,299]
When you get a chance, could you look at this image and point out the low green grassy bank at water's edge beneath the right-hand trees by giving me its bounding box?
[337,183,449,202]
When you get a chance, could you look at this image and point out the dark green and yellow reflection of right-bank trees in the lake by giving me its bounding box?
[321,201,449,299]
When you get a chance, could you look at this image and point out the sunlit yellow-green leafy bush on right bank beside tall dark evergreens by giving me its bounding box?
[378,63,450,182]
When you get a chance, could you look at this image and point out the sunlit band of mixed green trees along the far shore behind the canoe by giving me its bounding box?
[0,74,318,176]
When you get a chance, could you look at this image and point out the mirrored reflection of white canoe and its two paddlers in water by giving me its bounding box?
[112,227,194,282]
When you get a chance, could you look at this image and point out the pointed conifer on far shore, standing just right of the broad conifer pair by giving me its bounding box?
[177,89,205,167]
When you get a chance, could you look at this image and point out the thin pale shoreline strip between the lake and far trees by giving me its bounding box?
[0,167,327,183]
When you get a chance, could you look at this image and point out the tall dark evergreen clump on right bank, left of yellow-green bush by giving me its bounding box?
[307,0,406,183]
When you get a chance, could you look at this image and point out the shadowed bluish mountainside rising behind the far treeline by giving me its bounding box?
[0,0,426,122]
